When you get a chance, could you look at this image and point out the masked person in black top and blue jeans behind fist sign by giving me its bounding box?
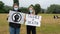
[9,3,21,34]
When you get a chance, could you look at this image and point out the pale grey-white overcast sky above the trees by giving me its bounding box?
[0,0,60,9]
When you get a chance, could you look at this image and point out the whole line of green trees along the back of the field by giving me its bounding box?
[0,1,60,14]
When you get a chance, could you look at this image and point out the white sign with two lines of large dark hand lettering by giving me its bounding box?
[25,14,41,27]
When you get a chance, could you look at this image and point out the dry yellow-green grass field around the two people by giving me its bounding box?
[0,14,60,34]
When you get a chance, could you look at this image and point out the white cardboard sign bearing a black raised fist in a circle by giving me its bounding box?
[8,11,25,24]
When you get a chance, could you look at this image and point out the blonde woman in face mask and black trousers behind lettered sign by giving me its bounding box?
[26,6,36,34]
